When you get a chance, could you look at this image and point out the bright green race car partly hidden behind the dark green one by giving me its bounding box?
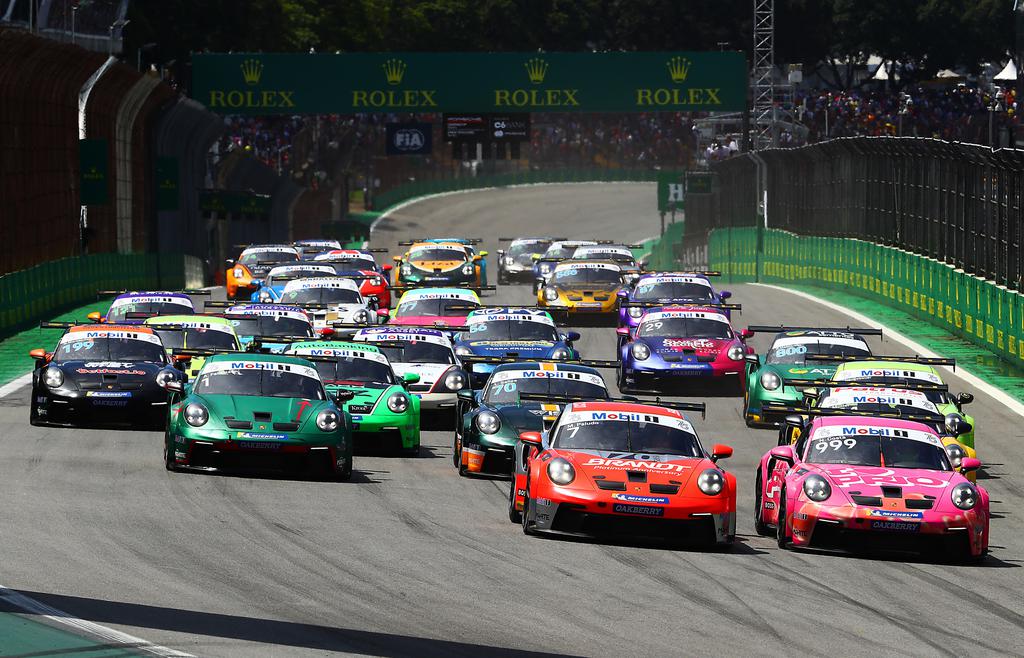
[285,341,420,456]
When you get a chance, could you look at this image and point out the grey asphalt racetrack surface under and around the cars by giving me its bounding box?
[0,184,1024,656]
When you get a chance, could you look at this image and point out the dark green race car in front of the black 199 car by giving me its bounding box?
[164,354,352,480]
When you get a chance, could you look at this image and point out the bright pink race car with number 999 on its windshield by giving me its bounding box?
[754,417,989,561]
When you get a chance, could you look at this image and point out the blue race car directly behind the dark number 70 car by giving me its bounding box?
[454,306,580,388]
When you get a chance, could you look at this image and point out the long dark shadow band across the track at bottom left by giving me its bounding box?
[4,590,573,658]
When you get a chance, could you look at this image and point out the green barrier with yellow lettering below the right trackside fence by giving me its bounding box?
[708,227,1024,365]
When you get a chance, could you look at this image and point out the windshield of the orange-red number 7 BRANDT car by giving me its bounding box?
[552,421,701,457]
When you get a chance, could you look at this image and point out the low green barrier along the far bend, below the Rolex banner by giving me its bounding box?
[374,168,657,211]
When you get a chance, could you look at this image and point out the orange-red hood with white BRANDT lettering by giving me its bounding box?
[554,450,715,492]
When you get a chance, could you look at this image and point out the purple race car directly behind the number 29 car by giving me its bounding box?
[618,272,732,328]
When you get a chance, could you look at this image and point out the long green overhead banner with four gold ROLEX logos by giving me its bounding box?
[193,52,748,115]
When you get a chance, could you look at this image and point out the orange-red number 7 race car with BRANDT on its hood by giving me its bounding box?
[509,394,736,545]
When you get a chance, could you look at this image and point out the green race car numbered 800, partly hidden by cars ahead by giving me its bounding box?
[743,325,882,428]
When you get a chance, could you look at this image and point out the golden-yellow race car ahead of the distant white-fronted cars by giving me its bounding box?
[537,260,625,323]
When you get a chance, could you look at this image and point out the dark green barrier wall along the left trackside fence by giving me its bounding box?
[0,254,195,336]
